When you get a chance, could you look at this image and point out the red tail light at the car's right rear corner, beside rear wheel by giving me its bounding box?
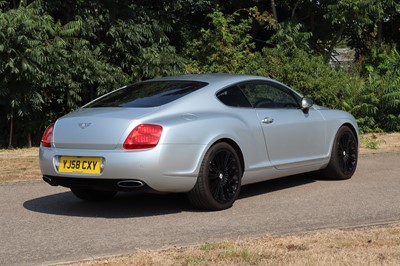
[123,124,162,150]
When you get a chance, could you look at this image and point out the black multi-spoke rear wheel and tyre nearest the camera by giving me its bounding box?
[188,142,243,211]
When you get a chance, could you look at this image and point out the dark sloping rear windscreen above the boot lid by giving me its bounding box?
[85,80,207,108]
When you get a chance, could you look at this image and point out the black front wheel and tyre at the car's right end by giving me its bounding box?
[322,126,358,180]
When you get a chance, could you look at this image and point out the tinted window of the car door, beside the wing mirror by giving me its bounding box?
[240,81,299,108]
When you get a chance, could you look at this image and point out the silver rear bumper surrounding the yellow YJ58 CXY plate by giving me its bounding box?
[40,145,204,192]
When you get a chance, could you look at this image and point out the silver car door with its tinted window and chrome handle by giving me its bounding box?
[241,81,326,169]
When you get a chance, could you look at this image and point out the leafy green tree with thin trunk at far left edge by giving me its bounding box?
[0,3,72,147]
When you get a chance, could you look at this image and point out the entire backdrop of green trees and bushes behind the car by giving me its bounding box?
[0,0,400,146]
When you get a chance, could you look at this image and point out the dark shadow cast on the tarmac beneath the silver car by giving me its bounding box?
[23,174,316,218]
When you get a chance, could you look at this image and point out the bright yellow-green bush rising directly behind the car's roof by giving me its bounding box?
[185,9,256,73]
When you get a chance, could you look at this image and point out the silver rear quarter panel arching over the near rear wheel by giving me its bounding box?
[137,90,270,182]
